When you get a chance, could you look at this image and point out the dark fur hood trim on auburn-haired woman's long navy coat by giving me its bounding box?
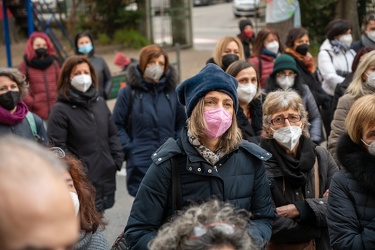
[126,63,179,90]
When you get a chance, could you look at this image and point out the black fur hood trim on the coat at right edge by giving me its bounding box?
[336,133,375,193]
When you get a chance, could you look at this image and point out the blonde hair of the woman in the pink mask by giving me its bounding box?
[187,97,242,153]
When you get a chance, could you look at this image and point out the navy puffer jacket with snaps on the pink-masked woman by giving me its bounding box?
[125,130,274,250]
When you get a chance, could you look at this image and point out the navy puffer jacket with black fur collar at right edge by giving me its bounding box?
[327,133,375,250]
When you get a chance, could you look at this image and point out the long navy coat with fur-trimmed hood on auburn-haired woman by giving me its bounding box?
[113,63,186,196]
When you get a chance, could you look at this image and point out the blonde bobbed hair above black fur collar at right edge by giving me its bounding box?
[345,94,375,143]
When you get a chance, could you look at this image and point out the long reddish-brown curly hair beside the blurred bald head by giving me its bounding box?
[63,154,105,232]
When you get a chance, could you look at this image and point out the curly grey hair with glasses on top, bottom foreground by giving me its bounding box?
[149,200,258,250]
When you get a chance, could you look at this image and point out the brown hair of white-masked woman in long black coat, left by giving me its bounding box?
[56,56,98,97]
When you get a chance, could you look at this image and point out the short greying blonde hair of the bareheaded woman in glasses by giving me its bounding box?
[263,89,309,139]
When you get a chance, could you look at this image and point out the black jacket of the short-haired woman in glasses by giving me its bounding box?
[261,138,338,250]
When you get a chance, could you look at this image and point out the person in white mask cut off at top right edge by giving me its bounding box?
[351,12,375,52]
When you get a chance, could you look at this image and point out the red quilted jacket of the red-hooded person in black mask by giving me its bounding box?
[18,60,60,120]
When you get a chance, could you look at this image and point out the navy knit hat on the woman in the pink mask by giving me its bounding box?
[176,63,238,117]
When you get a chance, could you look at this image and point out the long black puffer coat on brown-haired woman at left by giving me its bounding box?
[47,88,124,209]
